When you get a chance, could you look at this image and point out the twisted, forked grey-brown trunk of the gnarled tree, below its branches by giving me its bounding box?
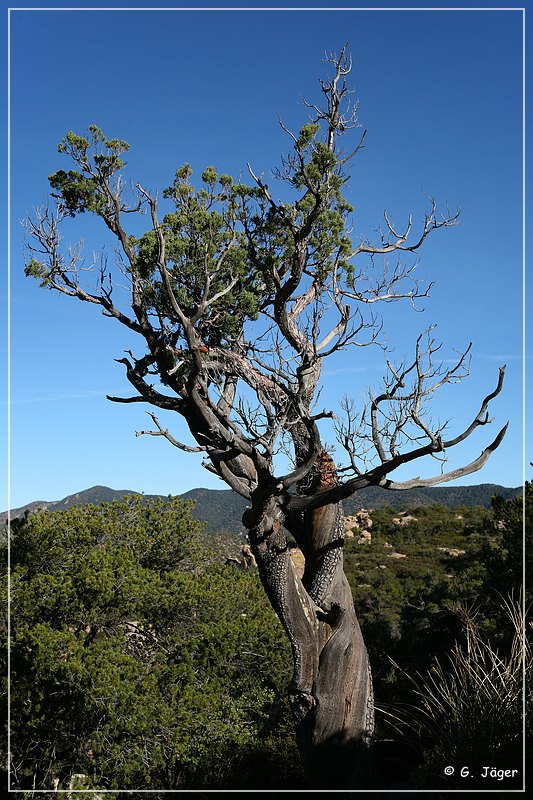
[246,454,374,789]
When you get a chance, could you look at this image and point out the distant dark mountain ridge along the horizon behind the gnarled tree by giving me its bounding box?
[0,483,523,533]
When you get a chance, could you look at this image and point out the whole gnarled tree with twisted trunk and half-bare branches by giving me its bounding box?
[26,50,505,788]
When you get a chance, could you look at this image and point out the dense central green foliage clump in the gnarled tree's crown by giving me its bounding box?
[136,164,263,346]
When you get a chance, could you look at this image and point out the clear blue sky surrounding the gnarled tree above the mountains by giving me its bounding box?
[0,3,533,508]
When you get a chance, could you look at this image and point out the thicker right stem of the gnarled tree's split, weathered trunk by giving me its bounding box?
[287,451,374,789]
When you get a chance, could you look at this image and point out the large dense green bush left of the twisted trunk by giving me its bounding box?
[4,497,294,791]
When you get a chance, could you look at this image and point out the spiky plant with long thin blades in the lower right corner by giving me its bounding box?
[381,595,533,790]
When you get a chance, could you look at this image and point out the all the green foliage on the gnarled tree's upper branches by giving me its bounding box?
[25,110,362,354]
